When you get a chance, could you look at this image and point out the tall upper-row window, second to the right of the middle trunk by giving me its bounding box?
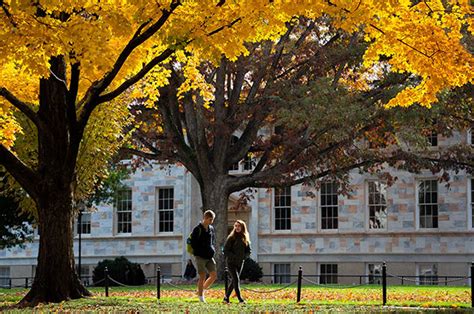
[321,182,338,229]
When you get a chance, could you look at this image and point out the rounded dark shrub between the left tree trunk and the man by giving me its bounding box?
[92,256,145,286]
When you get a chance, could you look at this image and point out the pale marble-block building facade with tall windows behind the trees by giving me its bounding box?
[0,132,474,286]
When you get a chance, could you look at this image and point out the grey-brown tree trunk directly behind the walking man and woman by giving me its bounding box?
[201,180,230,278]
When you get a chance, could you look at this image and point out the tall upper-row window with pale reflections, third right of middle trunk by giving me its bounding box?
[368,181,387,229]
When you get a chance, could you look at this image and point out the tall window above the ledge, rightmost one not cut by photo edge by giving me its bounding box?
[418,180,438,228]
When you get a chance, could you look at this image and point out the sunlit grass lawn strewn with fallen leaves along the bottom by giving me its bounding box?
[0,284,471,313]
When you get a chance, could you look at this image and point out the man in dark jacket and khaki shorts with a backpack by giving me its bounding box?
[191,210,217,302]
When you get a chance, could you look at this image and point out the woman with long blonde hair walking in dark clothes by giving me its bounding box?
[224,220,250,303]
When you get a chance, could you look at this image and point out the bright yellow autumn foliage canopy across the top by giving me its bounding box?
[0,0,473,147]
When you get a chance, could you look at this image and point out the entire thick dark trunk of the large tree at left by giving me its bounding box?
[20,57,90,306]
